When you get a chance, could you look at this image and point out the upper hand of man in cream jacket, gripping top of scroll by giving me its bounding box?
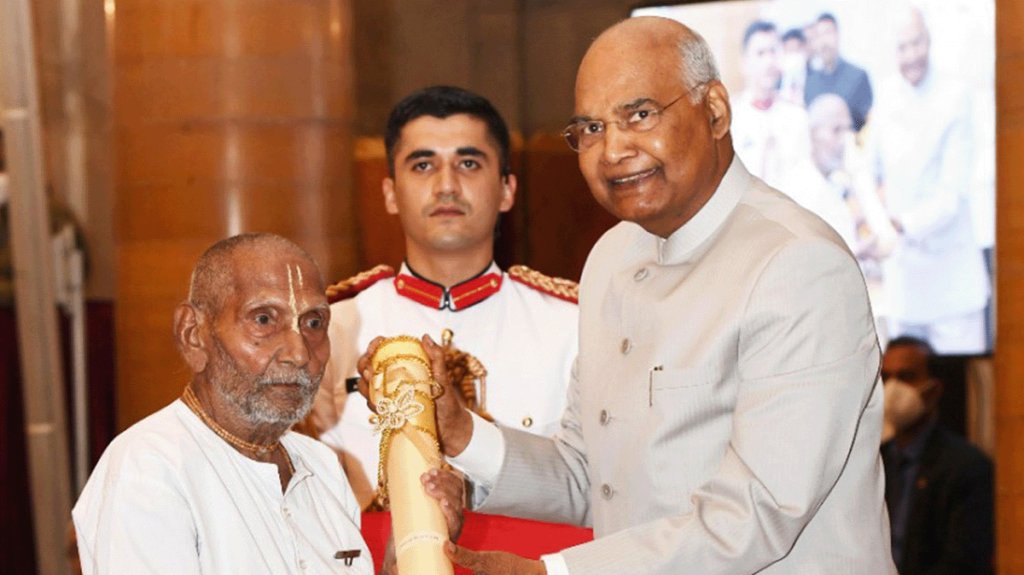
[357,336,473,457]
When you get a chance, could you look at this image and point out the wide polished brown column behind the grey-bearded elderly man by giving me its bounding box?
[112,0,356,428]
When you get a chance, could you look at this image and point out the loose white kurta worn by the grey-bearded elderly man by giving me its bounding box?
[73,401,373,575]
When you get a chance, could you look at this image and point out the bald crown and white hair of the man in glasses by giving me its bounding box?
[577,16,720,102]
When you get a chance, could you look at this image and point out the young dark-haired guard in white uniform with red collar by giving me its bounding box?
[315,87,578,506]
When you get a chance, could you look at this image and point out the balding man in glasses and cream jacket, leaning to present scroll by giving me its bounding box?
[428,18,895,575]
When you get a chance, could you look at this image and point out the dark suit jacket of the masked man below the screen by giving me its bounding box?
[882,426,994,575]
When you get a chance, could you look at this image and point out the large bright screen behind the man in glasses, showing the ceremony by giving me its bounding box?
[632,0,995,355]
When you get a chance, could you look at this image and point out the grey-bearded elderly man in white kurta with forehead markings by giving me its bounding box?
[73,234,462,575]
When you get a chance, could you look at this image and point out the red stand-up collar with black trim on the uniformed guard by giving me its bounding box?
[394,262,503,311]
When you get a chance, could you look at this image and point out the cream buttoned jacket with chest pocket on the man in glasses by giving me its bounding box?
[454,156,891,575]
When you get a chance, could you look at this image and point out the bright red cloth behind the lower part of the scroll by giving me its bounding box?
[362,512,594,575]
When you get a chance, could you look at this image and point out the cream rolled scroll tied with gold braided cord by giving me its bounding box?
[370,336,454,575]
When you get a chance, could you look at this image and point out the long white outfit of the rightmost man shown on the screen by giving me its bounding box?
[868,73,989,343]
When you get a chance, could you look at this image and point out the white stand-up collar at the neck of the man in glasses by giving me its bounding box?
[652,156,753,265]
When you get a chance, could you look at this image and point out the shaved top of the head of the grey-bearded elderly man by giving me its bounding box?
[188,233,323,315]
